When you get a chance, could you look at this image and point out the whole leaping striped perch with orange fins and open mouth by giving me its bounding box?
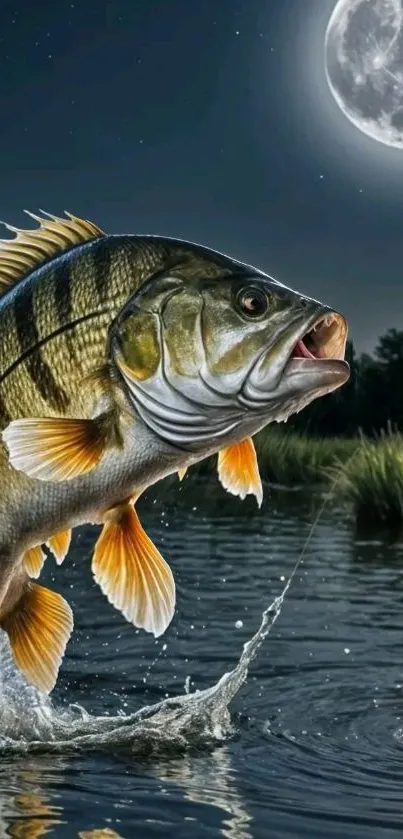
[0,211,350,692]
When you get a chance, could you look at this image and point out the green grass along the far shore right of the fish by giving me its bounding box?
[200,426,403,526]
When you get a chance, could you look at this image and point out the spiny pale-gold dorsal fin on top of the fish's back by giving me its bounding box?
[0,210,105,294]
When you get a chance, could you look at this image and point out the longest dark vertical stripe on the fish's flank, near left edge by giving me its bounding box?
[14,283,69,410]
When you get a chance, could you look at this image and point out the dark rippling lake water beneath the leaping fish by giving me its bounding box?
[0,477,403,839]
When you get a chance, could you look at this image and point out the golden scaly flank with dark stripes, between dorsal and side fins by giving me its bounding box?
[0,236,170,429]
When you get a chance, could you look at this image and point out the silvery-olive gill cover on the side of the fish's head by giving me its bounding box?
[110,277,245,448]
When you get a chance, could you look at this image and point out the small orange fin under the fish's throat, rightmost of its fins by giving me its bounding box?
[217,437,263,507]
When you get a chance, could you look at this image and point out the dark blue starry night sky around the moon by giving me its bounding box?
[0,0,403,350]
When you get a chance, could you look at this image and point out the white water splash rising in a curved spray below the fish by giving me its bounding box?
[0,572,288,755]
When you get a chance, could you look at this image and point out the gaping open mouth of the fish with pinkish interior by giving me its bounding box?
[290,312,347,360]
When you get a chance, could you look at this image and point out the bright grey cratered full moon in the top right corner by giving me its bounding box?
[325,0,403,149]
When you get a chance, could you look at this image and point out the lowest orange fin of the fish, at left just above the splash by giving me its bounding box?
[1,582,73,693]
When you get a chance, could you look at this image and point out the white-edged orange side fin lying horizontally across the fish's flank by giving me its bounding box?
[3,416,113,481]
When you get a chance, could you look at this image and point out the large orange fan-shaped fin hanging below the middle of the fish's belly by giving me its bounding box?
[92,502,175,637]
